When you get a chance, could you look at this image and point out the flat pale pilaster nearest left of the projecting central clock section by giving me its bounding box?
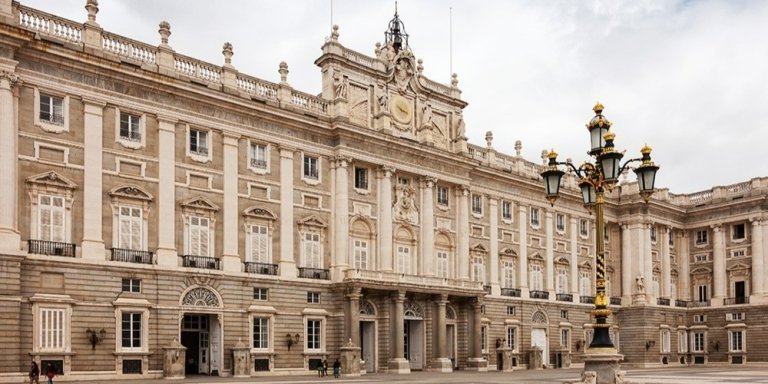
[280,148,296,277]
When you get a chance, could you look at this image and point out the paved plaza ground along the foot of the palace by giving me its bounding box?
[108,367,768,384]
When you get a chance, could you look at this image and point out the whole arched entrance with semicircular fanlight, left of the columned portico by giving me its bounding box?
[179,286,224,375]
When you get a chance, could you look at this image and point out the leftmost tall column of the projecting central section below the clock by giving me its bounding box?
[331,156,352,282]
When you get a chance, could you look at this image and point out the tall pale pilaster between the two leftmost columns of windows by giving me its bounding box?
[82,99,106,260]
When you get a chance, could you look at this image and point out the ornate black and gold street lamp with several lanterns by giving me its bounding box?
[541,103,659,351]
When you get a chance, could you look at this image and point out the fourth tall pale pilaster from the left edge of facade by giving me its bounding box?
[221,133,243,272]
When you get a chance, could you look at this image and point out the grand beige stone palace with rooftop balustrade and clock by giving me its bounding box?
[0,0,768,382]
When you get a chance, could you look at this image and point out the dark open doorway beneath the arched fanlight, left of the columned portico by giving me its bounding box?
[181,313,221,375]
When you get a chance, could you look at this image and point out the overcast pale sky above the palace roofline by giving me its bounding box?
[21,0,768,193]
